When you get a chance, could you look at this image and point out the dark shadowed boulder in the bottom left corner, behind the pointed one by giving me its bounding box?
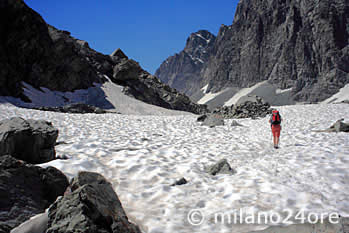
[0,155,69,232]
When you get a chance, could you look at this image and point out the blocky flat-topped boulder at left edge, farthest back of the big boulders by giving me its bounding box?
[0,117,58,163]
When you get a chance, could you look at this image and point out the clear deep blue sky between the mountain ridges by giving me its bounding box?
[24,0,238,73]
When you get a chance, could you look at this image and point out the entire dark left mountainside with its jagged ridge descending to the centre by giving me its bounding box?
[0,0,205,113]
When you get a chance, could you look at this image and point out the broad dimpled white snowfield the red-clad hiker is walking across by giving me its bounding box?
[0,104,349,233]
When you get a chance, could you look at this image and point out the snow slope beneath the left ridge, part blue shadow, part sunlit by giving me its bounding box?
[0,76,190,115]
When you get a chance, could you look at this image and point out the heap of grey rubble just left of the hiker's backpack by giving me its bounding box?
[213,96,271,119]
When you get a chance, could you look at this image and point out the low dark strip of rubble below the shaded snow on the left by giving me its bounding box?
[35,103,108,114]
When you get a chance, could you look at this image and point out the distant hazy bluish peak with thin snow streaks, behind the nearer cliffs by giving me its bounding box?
[155,30,216,95]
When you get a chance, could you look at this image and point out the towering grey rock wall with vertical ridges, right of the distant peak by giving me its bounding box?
[156,0,349,102]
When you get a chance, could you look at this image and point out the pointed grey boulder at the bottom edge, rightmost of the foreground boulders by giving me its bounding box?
[46,172,140,233]
